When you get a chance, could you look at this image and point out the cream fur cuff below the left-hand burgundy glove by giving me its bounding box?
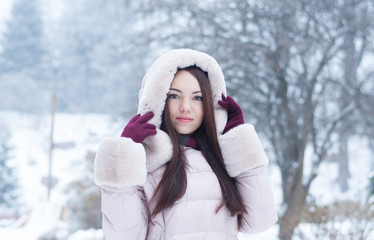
[94,137,147,187]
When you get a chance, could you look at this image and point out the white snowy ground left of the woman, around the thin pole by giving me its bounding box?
[0,111,123,240]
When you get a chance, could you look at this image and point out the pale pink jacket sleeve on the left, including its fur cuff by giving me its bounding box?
[94,137,149,240]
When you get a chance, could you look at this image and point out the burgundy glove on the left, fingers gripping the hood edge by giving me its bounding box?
[121,112,157,143]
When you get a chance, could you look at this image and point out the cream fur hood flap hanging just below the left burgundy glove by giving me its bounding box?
[143,129,173,172]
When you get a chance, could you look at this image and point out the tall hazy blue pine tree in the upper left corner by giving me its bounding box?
[0,0,49,112]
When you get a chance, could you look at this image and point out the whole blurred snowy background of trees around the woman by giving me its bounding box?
[0,0,374,240]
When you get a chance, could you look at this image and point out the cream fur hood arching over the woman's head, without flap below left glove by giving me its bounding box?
[138,49,227,134]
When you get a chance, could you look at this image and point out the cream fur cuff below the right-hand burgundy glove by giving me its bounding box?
[218,124,269,177]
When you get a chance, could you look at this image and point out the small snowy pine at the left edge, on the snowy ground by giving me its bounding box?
[0,129,17,207]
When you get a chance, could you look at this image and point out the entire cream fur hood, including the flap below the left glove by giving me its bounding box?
[138,49,227,172]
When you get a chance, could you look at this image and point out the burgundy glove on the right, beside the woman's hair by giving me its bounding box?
[218,94,244,134]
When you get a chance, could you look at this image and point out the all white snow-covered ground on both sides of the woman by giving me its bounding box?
[0,111,373,240]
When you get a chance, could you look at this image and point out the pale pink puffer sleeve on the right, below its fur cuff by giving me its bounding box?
[236,166,278,233]
